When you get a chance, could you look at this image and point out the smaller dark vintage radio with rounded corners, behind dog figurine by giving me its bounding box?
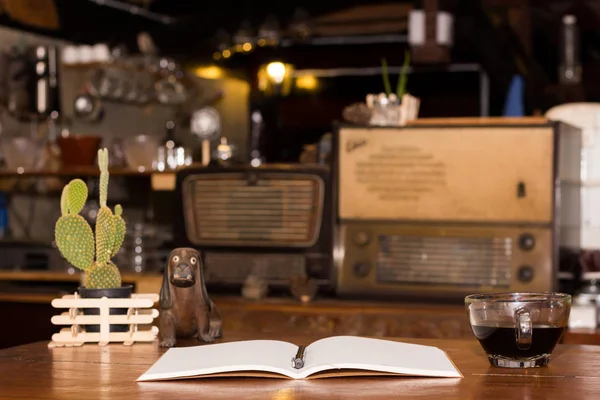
[175,164,333,288]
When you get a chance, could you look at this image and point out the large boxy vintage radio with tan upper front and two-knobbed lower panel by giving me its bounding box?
[334,118,581,299]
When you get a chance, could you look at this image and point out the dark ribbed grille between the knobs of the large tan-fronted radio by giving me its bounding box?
[377,236,513,288]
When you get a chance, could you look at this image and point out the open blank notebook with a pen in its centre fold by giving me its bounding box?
[137,336,462,382]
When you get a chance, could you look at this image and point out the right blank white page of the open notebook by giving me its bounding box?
[304,336,461,377]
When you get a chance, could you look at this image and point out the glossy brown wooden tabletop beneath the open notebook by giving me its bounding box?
[0,335,600,400]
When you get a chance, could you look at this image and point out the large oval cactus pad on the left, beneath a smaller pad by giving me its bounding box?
[54,214,94,271]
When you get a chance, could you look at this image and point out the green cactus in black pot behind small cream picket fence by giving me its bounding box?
[54,149,132,332]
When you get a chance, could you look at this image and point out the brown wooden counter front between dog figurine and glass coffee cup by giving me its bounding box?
[214,297,472,339]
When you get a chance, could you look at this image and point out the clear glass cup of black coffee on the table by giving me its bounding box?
[465,293,571,368]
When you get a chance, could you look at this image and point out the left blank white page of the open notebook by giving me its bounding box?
[138,340,298,380]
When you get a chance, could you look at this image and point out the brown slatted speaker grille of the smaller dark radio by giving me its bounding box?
[182,172,324,248]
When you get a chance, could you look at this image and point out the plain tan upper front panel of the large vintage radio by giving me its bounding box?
[334,126,554,223]
